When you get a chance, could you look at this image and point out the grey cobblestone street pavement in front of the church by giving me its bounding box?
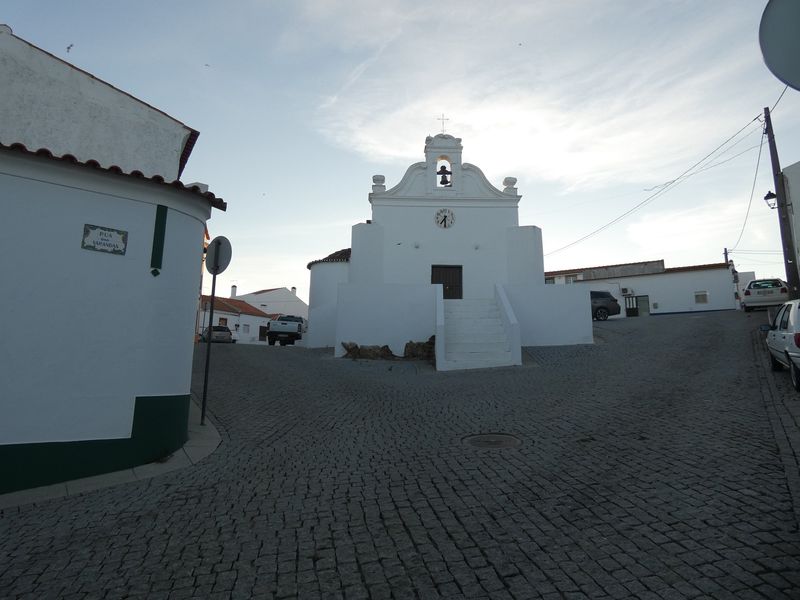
[0,312,800,600]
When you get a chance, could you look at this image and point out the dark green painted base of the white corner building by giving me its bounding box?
[0,394,189,494]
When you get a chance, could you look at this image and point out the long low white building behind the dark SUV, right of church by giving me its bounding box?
[545,260,738,318]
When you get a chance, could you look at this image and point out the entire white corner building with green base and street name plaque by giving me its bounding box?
[0,25,225,493]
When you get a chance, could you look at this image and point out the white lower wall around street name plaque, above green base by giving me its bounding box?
[0,152,210,444]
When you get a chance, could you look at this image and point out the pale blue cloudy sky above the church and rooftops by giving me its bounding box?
[0,0,800,301]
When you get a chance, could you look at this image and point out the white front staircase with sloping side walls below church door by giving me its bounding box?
[437,299,515,371]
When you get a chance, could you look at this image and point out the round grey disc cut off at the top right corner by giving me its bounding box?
[758,0,800,90]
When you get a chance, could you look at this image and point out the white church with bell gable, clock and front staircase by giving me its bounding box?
[307,134,593,370]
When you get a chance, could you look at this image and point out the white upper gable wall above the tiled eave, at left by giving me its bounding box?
[0,27,191,181]
